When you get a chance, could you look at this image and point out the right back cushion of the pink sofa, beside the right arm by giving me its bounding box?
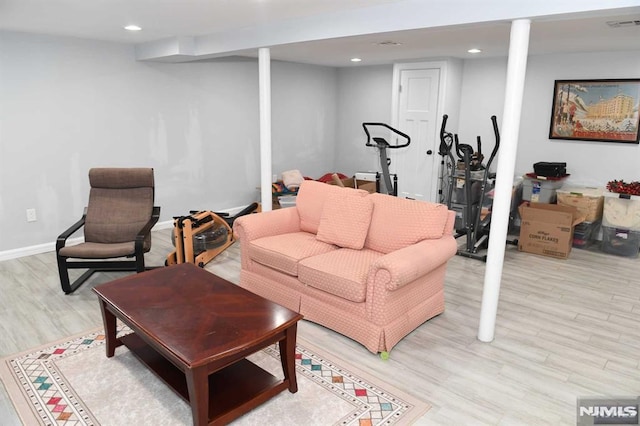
[364,194,449,253]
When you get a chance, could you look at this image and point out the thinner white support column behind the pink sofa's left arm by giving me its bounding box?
[258,47,271,211]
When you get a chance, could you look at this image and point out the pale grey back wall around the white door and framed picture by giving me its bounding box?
[336,51,640,187]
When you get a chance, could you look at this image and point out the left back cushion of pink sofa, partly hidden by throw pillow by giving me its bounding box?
[296,180,367,234]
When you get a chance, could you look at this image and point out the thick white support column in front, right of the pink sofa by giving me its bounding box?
[478,19,531,342]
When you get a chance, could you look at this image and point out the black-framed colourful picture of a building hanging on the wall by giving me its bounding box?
[549,79,640,143]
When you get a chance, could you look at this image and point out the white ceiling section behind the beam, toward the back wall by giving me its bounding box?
[264,13,640,67]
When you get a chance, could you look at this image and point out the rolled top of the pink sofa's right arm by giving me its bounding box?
[369,235,457,291]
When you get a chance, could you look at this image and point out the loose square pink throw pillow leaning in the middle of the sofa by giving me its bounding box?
[316,191,373,250]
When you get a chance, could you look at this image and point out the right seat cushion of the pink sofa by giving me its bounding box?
[298,248,383,303]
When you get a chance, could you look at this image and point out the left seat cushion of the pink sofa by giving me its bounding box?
[248,232,337,276]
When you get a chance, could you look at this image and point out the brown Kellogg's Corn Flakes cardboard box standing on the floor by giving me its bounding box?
[518,203,584,259]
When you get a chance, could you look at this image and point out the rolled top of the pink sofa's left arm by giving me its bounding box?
[233,207,300,241]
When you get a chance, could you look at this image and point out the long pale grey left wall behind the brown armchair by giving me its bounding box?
[0,32,337,253]
